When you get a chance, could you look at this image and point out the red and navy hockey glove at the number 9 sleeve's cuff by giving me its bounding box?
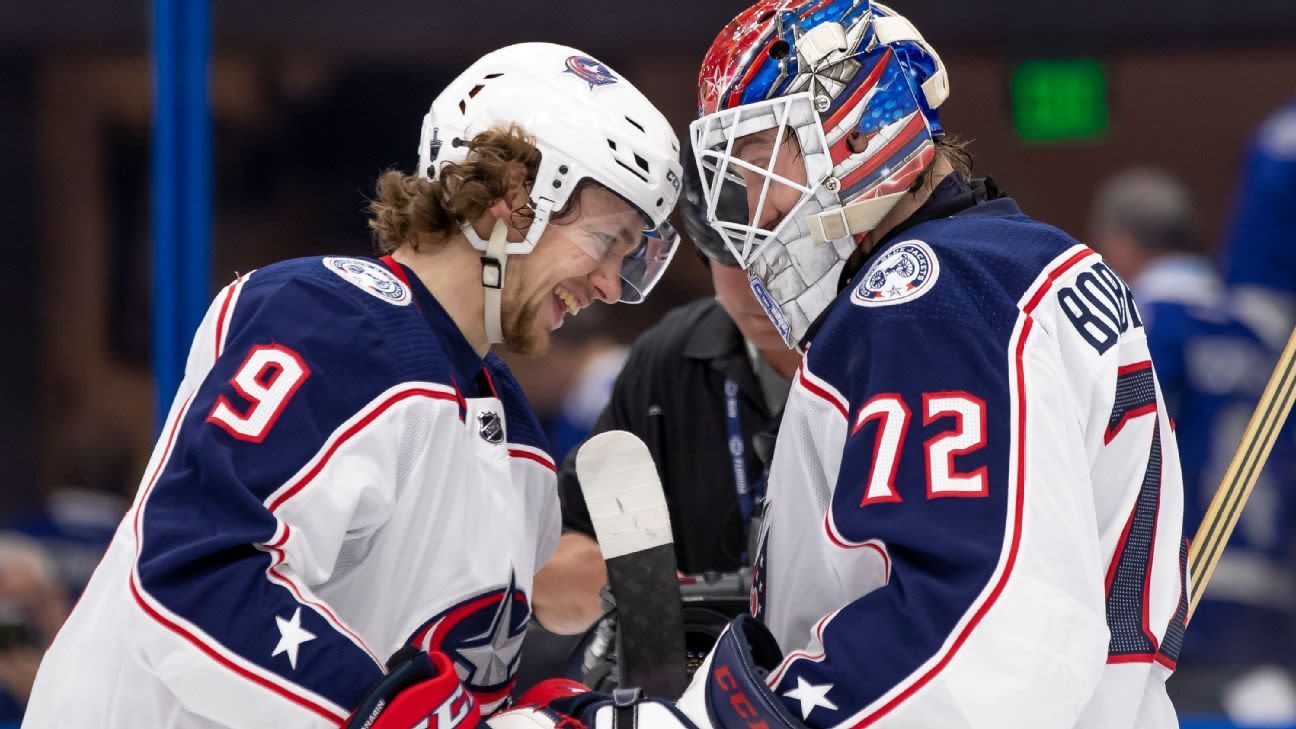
[343,646,481,729]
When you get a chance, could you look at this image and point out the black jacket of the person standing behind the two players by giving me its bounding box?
[559,298,774,573]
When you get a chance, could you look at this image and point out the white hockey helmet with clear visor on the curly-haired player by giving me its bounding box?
[419,43,682,341]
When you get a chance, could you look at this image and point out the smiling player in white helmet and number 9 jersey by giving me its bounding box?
[25,44,680,729]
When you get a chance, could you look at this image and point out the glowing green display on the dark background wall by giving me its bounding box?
[1010,58,1108,143]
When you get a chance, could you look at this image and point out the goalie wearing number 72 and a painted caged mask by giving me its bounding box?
[682,0,1186,729]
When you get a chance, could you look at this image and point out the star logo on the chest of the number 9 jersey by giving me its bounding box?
[410,573,531,713]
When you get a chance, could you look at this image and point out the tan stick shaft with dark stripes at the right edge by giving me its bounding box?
[1188,329,1296,620]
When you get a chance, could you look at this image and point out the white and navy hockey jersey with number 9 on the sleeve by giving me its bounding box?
[23,258,559,729]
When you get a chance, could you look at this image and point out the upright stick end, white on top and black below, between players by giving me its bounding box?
[575,431,686,699]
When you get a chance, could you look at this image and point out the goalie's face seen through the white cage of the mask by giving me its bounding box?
[732,128,806,231]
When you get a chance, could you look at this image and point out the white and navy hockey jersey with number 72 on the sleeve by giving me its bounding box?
[693,184,1187,729]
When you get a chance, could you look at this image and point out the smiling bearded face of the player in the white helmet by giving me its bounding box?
[502,185,644,355]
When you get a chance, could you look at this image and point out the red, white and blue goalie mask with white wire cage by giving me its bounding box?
[689,0,949,346]
